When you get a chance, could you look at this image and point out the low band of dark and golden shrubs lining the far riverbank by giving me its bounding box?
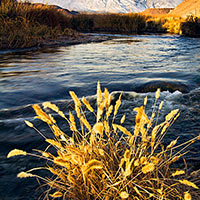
[65,13,200,37]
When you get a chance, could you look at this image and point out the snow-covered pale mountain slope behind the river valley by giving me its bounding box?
[30,0,183,13]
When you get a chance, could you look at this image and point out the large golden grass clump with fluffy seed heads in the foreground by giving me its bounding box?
[8,83,200,200]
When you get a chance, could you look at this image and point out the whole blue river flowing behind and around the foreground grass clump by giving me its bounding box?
[0,35,200,200]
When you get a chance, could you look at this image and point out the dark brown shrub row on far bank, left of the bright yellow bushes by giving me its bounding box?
[71,14,146,34]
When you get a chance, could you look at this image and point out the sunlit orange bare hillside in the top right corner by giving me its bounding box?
[169,0,200,17]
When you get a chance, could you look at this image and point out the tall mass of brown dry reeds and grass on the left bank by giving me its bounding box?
[0,0,77,49]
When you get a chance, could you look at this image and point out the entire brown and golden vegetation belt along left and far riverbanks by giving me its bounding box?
[0,0,200,49]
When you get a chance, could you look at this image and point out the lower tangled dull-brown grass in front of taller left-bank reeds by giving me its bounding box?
[0,16,77,49]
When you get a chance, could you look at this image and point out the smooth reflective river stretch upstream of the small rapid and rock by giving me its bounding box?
[0,35,200,108]
